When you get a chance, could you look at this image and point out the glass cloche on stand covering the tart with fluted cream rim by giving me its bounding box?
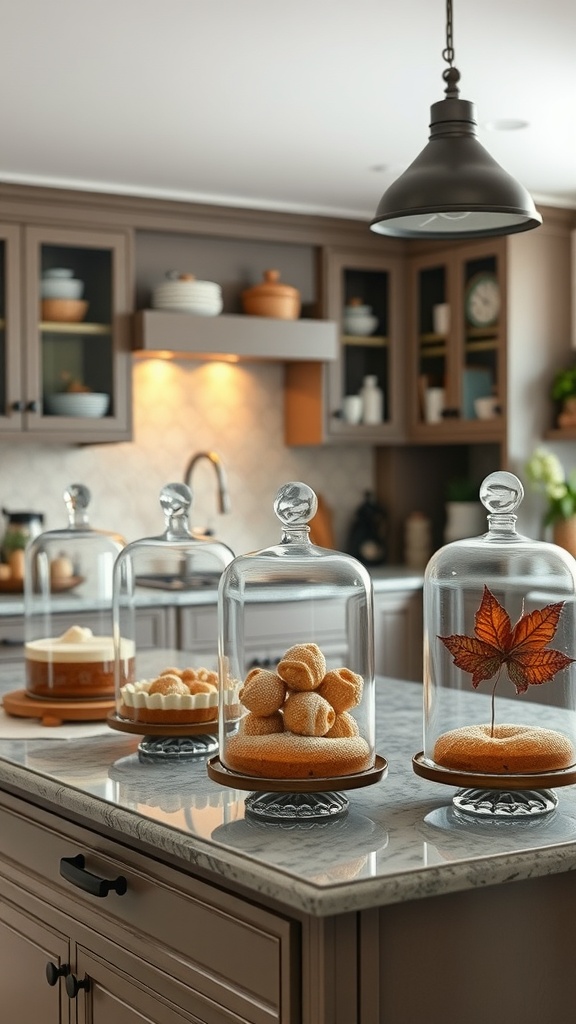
[109,483,234,760]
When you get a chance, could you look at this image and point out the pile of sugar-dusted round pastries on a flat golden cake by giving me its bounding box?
[222,643,373,779]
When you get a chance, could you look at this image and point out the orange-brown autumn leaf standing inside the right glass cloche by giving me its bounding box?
[438,586,574,693]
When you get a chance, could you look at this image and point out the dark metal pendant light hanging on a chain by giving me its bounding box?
[370,0,542,239]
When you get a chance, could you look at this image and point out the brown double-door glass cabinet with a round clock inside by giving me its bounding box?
[408,239,506,443]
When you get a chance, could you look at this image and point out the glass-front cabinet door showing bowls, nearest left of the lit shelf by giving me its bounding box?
[20,226,131,441]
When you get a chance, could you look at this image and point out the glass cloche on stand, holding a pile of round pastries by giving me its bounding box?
[208,482,385,820]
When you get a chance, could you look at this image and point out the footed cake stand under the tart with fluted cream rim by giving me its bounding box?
[107,710,218,764]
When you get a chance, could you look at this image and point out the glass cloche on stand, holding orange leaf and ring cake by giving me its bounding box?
[413,472,576,817]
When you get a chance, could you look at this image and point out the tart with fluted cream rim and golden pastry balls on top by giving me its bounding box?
[119,668,218,725]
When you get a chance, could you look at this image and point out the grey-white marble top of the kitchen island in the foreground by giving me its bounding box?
[0,679,576,915]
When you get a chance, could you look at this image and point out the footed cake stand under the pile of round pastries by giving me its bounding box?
[206,755,387,823]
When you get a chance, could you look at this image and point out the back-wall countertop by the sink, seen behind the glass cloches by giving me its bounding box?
[0,565,424,616]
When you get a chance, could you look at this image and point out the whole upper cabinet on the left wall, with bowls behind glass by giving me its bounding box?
[0,225,131,443]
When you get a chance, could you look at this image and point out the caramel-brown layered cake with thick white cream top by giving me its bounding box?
[25,626,134,700]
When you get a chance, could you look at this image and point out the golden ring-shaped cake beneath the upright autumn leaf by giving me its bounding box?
[434,725,576,775]
